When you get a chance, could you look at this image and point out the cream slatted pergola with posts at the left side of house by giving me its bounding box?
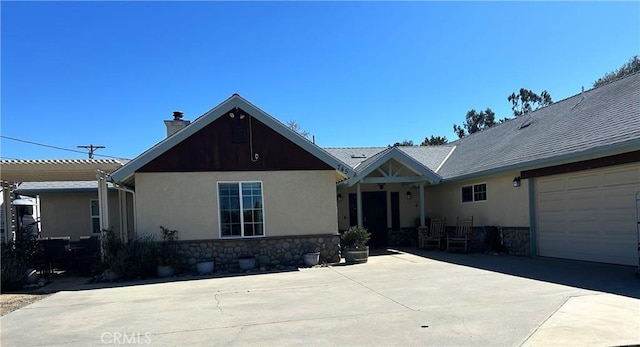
[0,159,124,242]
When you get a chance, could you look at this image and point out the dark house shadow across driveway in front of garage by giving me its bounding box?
[398,248,640,299]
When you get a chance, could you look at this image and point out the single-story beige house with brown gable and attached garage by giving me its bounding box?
[2,73,640,265]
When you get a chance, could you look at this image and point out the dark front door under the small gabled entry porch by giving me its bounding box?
[349,192,388,248]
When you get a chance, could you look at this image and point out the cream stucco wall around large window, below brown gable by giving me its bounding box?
[135,170,338,240]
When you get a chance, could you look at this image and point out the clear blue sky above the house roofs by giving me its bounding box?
[0,1,640,159]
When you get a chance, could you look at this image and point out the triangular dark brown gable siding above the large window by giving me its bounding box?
[138,109,333,172]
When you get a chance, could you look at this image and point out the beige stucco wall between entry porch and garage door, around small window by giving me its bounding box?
[426,172,529,227]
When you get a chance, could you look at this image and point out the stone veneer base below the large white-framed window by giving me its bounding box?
[178,234,340,270]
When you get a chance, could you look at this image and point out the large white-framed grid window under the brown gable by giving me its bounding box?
[218,182,264,237]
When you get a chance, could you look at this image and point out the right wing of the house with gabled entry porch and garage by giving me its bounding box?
[327,73,640,265]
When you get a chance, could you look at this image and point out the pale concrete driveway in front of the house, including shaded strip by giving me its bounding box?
[0,249,640,346]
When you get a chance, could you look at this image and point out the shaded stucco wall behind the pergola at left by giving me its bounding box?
[40,191,120,240]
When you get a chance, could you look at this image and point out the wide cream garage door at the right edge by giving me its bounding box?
[536,164,640,265]
